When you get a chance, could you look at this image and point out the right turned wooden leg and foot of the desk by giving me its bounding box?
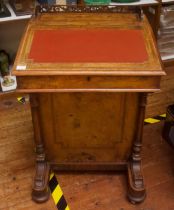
[128,94,146,203]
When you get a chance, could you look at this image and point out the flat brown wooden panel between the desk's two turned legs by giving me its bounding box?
[38,93,139,163]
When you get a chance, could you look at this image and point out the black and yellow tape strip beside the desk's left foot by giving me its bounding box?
[49,172,70,210]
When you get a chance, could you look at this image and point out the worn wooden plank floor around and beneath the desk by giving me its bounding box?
[0,95,174,210]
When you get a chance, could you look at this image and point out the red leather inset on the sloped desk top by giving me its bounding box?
[29,29,148,63]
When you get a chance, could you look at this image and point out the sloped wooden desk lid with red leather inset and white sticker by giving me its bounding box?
[13,6,164,75]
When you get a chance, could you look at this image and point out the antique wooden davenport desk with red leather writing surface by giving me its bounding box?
[13,6,165,203]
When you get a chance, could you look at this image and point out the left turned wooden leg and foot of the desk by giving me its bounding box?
[30,94,50,203]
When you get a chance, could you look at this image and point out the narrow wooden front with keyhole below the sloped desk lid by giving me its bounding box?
[17,75,160,92]
